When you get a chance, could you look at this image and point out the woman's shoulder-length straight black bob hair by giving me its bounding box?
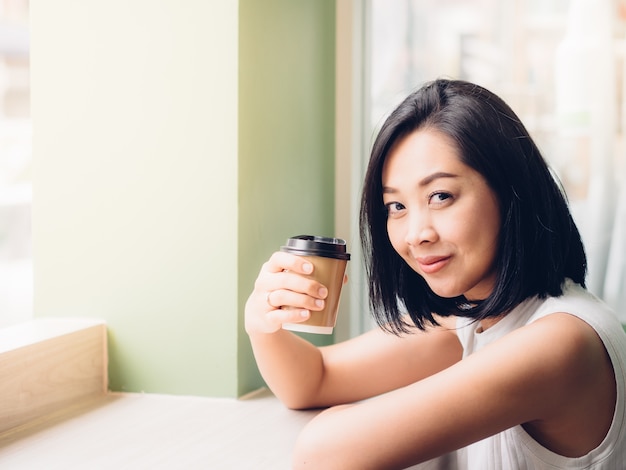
[360,79,587,334]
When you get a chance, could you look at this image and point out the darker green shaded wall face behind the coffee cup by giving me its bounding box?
[239,0,335,392]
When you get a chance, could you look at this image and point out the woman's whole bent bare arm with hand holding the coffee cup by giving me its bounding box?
[246,253,461,408]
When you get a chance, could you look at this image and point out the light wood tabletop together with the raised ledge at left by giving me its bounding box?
[0,319,317,470]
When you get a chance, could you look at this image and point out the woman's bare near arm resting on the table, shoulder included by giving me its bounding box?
[294,314,615,470]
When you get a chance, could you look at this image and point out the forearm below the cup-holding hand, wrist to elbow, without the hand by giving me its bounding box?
[249,330,324,409]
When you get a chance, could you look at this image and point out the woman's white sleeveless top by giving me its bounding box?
[411,281,626,470]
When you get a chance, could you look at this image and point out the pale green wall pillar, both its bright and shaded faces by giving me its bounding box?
[31,0,334,396]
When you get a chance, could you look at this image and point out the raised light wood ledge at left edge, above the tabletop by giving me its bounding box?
[0,318,107,432]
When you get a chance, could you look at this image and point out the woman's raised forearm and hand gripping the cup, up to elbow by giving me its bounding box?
[244,252,342,408]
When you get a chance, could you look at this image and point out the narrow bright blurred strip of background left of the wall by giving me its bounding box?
[0,0,33,326]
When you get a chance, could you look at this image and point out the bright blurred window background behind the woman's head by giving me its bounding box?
[366,0,626,322]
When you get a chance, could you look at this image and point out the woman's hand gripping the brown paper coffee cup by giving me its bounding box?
[245,251,328,334]
